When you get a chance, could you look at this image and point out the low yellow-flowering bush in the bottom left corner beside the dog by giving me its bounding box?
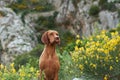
[0,63,39,80]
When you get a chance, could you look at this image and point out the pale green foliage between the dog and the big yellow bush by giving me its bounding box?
[59,50,80,80]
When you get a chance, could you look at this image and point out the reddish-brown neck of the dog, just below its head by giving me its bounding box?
[44,45,56,56]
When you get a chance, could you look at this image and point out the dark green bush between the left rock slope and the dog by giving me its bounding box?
[14,45,43,69]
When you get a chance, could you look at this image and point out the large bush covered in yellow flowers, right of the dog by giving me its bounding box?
[72,30,120,80]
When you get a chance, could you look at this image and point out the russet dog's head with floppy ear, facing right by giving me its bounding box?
[41,30,60,44]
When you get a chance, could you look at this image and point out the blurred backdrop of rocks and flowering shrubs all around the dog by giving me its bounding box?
[0,0,120,80]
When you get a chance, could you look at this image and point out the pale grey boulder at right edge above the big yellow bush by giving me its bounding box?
[99,11,119,29]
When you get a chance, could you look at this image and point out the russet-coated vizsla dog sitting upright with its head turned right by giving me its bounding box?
[39,30,60,80]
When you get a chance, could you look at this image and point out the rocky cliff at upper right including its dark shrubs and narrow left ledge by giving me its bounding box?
[25,0,120,36]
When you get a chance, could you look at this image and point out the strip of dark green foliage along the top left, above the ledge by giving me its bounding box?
[8,0,54,13]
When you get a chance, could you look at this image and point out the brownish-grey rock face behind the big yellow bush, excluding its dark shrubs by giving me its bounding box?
[56,0,120,36]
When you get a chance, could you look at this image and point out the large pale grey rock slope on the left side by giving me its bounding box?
[0,7,37,64]
